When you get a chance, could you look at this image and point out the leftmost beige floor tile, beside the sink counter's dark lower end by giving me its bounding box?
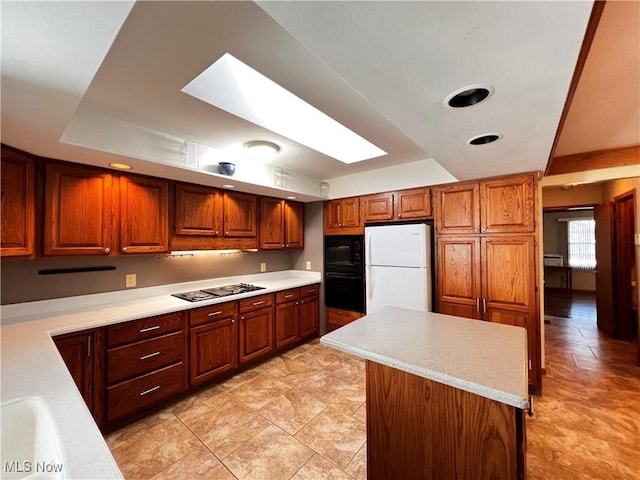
[111,417,200,480]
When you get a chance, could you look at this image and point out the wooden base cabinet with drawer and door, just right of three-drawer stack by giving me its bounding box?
[189,302,238,385]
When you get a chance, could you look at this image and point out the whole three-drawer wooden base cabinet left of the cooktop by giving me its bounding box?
[106,312,187,422]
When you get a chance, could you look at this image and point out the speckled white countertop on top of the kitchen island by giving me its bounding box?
[320,307,529,409]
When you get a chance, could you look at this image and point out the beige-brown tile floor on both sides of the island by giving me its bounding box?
[107,296,640,480]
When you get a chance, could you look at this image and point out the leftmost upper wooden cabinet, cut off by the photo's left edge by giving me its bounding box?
[0,148,36,257]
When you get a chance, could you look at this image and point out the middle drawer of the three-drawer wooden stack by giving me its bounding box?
[107,331,185,385]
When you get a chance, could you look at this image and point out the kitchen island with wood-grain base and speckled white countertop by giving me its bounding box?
[321,307,529,480]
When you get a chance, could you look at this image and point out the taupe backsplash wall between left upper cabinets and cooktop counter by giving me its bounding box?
[0,251,295,305]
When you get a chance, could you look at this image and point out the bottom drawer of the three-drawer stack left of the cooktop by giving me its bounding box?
[107,362,187,422]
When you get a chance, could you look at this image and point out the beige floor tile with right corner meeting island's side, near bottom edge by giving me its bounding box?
[295,407,366,468]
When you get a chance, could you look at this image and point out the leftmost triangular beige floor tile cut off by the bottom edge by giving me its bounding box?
[151,445,235,480]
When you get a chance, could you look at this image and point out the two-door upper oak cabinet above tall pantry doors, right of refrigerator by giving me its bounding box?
[434,174,535,234]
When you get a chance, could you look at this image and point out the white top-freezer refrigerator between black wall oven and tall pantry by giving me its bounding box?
[364,223,432,314]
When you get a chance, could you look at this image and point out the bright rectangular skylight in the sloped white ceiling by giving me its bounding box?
[182,53,387,163]
